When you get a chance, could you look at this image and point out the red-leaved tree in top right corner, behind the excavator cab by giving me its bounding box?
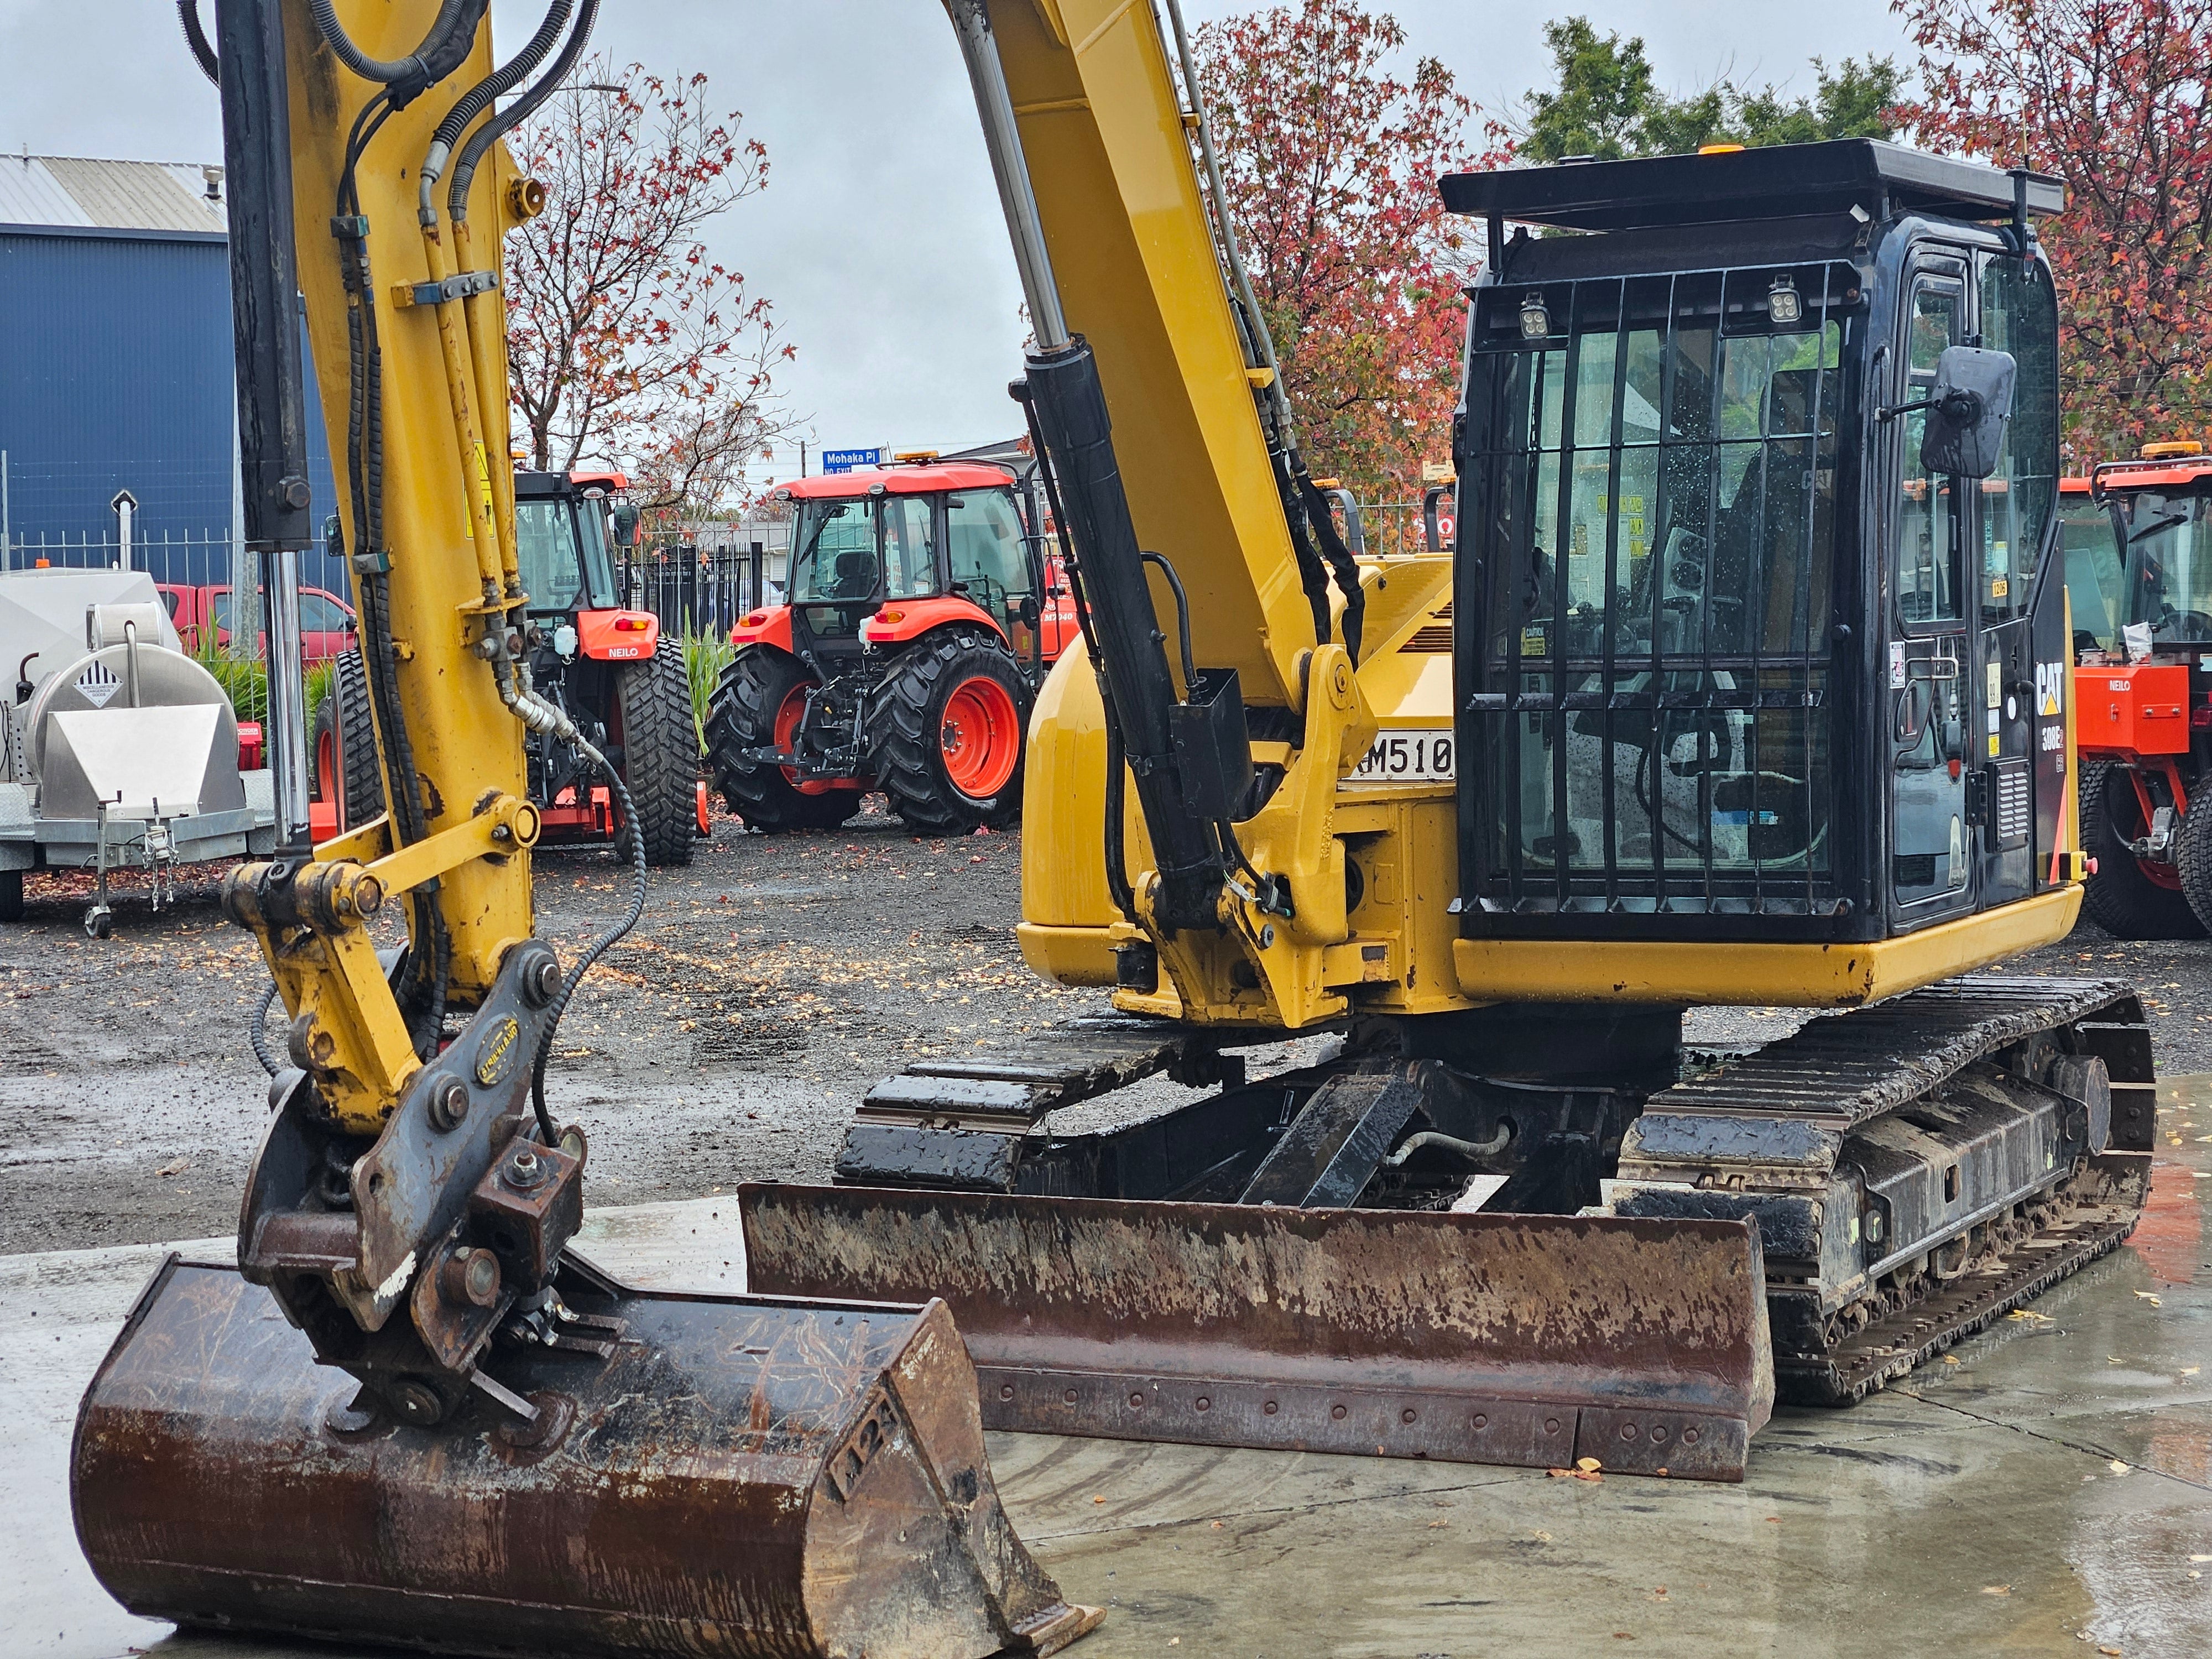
[1893,0,2212,456]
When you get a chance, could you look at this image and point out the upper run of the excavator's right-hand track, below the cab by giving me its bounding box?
[1644,975,2143,1130]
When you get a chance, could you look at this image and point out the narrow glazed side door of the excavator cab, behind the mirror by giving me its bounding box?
[1882,267,1980,927]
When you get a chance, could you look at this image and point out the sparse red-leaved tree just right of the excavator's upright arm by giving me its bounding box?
[504,60,792,515]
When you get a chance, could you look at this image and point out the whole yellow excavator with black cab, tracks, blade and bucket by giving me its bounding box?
[73,0,2152,1657]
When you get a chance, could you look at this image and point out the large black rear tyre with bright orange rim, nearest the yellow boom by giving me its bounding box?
[867,630,1033,836]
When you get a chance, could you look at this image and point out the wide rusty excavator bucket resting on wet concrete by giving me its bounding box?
[71,1256,1099,1659]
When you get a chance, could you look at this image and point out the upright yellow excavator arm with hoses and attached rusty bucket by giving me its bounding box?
[73,0,1102,1659]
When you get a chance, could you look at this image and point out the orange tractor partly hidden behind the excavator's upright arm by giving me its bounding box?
[314,471,708,865]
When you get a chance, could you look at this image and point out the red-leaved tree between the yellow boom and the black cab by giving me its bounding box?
[1192,0,1475,498]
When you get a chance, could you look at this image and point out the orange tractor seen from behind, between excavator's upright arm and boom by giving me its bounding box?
[706,456,1077,834]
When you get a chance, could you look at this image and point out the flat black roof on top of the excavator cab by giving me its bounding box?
[1438,139,2066,230]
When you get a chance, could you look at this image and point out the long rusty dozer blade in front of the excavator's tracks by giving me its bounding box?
[739,1186,1774,1480]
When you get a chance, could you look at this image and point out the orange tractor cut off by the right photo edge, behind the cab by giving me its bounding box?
[2062,442,2212,938]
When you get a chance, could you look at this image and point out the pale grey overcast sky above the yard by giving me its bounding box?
[0,0,1911,476]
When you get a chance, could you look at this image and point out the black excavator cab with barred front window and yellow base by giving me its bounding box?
[1444,142,2079,1004]
